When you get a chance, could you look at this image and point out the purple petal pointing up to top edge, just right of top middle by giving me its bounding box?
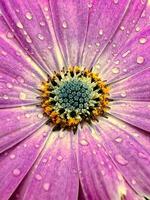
[82,0,134,67]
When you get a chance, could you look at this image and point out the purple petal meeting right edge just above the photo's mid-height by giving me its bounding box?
[110,68,150,102]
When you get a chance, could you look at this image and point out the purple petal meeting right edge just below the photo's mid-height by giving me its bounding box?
[109,101,150,131]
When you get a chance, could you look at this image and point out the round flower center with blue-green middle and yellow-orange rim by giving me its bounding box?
[41,66,109,132]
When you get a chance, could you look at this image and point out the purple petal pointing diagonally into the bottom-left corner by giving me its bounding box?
[0,126,49,200]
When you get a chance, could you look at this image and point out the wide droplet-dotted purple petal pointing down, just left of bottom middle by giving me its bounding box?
[11,132,79,200]
